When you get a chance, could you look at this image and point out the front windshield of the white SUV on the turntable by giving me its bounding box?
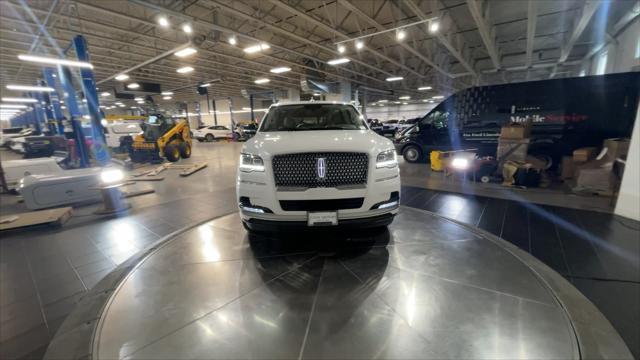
[260,104,367,131]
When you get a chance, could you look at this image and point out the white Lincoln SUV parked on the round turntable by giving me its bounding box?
[236,102,400,231]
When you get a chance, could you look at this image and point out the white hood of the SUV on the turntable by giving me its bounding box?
[242,130,394,158]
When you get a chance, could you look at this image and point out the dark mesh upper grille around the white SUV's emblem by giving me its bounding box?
[272,152,369,188]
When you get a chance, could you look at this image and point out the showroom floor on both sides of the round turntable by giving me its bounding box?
[0,143,640,358]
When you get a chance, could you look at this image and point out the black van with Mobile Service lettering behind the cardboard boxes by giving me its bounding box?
[395,72,640,164]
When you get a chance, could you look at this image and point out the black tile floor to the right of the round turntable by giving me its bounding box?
[401,186,640,358]
